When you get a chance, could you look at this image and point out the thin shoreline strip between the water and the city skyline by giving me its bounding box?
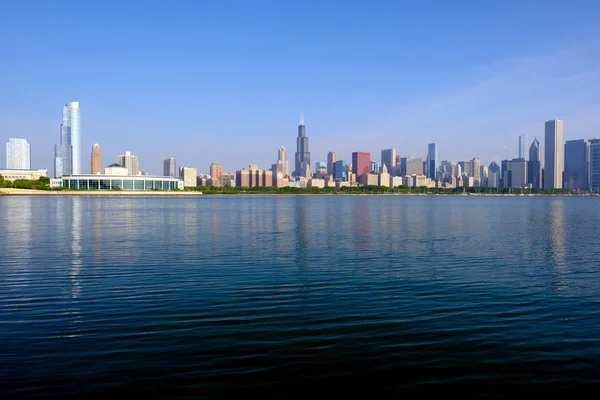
[0,188,600,197]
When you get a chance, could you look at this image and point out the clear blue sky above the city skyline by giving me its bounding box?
[0,0,600,174]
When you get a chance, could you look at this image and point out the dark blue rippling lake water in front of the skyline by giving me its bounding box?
[0,196,600,398]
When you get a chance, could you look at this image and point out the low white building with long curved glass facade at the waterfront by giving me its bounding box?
[62,175,183,190]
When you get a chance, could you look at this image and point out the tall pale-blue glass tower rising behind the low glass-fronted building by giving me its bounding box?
[54,101,81,177]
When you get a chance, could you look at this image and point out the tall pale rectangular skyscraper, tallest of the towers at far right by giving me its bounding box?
[544,119,564,189]
